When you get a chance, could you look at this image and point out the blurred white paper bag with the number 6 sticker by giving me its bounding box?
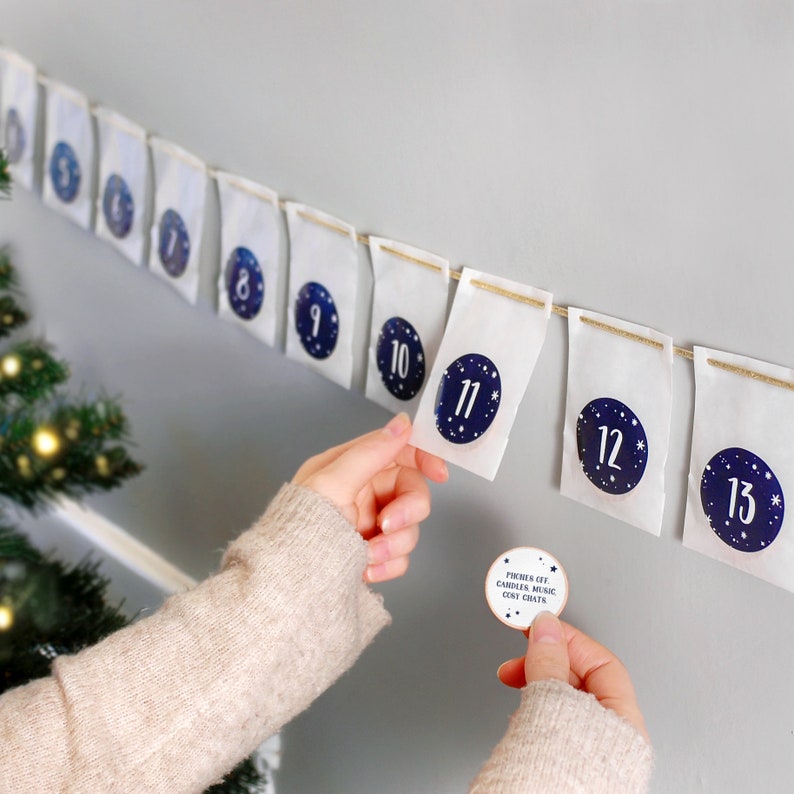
[95,108,149,265]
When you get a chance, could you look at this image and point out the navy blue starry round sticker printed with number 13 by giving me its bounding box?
[700,447,785,552]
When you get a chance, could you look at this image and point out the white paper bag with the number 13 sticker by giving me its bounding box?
[684,347,794,592]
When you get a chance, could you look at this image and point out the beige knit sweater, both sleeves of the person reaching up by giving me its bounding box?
[0,485,651,794]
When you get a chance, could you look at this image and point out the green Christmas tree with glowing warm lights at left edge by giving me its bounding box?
[0,150,266,794]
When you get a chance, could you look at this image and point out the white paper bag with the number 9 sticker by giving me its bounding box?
[286,202,358,389]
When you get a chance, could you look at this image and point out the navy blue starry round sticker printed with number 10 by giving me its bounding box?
[375,317,425,400]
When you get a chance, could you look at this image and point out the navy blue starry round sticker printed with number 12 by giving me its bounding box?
[576,397,648,494]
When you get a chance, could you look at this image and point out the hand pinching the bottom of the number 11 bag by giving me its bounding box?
[292,414,449,582]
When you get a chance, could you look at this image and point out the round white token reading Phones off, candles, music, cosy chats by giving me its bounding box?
[485,546,568,631]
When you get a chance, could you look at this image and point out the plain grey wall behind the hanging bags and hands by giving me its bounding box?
[0,0,794,794]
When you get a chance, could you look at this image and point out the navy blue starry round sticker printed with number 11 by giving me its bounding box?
[435,353,502,444]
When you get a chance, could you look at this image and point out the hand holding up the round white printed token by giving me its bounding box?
[497,612,650,742]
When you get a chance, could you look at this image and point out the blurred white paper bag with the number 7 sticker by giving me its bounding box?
[149,138,207,303]
